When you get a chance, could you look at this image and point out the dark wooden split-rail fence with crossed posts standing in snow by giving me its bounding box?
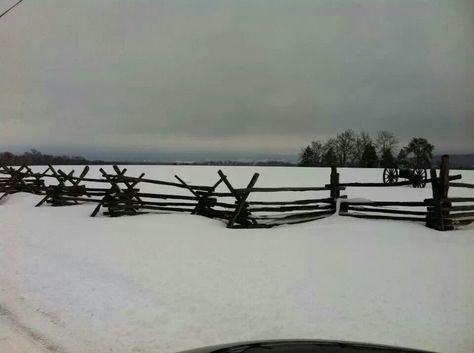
[0,156,474,231]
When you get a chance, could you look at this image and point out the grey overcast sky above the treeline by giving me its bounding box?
[0,0,474,160]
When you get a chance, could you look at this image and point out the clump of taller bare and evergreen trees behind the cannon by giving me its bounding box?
[299,129,434,168]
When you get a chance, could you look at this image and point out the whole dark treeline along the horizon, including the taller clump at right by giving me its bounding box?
[0,146,474,169]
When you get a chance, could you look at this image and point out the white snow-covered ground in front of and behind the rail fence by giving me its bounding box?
[0,166,474,353]
